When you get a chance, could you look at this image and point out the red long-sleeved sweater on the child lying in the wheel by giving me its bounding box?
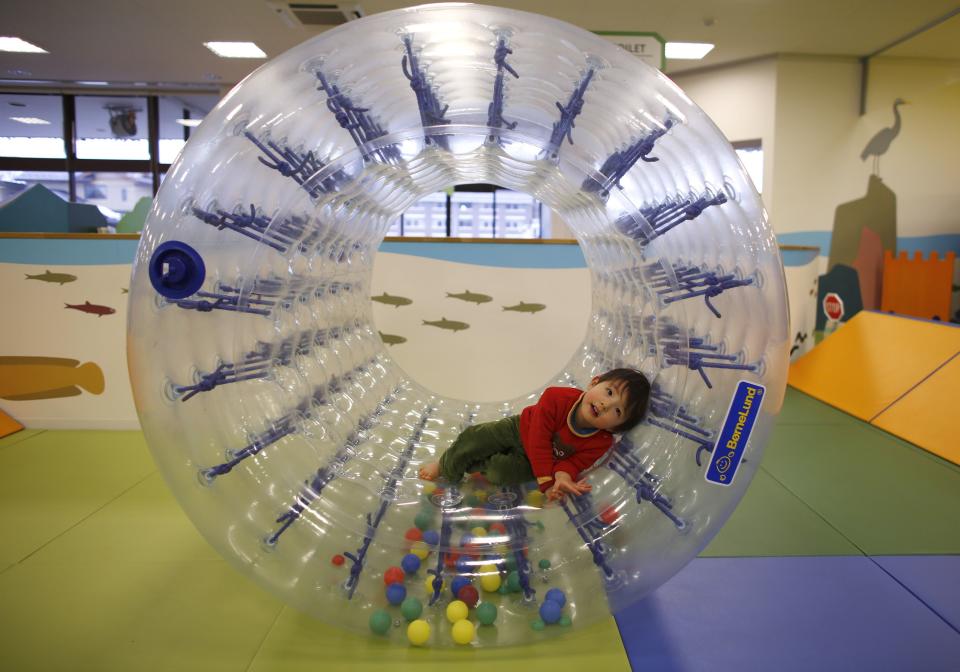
[520,387,613,492]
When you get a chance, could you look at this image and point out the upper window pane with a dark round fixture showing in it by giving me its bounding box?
[76,96,150,160]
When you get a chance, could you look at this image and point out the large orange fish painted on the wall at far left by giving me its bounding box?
[0,357,106,401]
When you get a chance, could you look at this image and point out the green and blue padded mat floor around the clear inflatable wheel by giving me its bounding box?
[0,389,960,672]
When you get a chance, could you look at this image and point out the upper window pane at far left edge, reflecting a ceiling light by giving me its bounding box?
[0,93,67,159]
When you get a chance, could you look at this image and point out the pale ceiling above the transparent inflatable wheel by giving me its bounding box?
[0,0,960,90]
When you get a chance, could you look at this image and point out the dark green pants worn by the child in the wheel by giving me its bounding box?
[440,415,534,485]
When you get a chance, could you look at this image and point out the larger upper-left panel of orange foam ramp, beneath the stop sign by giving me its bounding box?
[787,311,960,422]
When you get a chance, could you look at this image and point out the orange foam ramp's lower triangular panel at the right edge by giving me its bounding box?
[873,354,960,464]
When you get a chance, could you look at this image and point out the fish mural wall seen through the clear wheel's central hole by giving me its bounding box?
[371,243,590,401]
